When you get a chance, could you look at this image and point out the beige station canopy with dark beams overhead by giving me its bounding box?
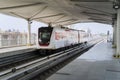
[0,0,117,25]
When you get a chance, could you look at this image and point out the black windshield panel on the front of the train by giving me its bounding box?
[38,27,52,46]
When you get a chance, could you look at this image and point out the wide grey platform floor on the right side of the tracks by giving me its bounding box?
[47,41,120,80]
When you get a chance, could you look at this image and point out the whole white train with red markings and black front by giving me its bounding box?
[37,27,86,50]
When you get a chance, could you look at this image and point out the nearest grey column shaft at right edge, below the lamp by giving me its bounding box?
[116,9,120,57]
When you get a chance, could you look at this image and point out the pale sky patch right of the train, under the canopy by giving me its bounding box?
[73,22,113,34]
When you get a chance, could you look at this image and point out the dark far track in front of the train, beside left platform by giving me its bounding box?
[0,43,84,71]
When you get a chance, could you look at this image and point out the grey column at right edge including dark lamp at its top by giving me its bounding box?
[113,1,120,58]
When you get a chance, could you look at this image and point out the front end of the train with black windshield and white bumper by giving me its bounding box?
[37,27,53,49]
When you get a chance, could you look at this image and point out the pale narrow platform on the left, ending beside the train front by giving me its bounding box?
[0,45,36,58]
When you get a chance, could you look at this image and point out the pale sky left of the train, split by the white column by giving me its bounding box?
[0,14,47,33]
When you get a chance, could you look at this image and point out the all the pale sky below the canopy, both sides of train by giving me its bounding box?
[0,14,112,34]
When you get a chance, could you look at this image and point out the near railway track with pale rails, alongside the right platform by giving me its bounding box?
[0,38,102,80]
